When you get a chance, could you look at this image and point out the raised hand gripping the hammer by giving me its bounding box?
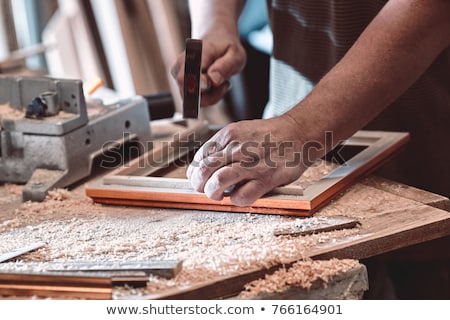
[171,28,246,106]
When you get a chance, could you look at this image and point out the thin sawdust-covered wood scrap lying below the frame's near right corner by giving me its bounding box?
[273,216,361,236]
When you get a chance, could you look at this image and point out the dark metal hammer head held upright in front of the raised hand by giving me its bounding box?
[183,39,202,119]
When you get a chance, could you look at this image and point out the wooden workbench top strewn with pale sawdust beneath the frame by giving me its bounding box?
[0,121,450,299]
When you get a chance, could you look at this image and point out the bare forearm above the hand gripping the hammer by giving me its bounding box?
[189,0,245,38]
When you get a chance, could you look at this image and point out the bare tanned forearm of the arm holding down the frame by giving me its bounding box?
[287,0,450,157]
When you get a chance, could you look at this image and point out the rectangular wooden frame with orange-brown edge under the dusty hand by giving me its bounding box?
[86,122,409,216]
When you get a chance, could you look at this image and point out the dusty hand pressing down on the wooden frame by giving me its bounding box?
[187,116,308,206]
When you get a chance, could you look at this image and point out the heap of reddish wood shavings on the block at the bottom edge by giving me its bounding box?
[238,259,359,299]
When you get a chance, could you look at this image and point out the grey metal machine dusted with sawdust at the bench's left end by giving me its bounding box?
[0,77,151,201]
